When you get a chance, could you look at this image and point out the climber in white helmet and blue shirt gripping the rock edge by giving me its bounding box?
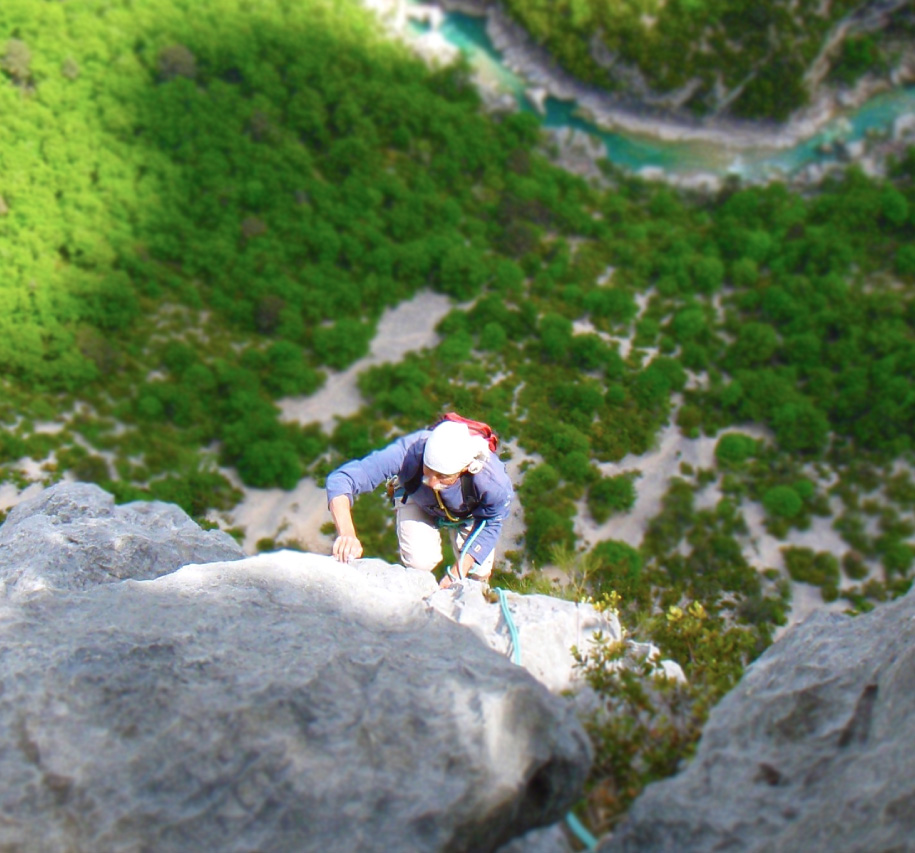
[327,414,514,587]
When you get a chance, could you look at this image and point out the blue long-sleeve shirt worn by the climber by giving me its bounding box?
[326,429,514,565]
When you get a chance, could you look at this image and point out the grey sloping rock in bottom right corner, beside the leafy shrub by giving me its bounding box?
[600,593,915,853]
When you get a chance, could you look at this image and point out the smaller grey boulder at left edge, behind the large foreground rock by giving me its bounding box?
[0,483,244,598]
